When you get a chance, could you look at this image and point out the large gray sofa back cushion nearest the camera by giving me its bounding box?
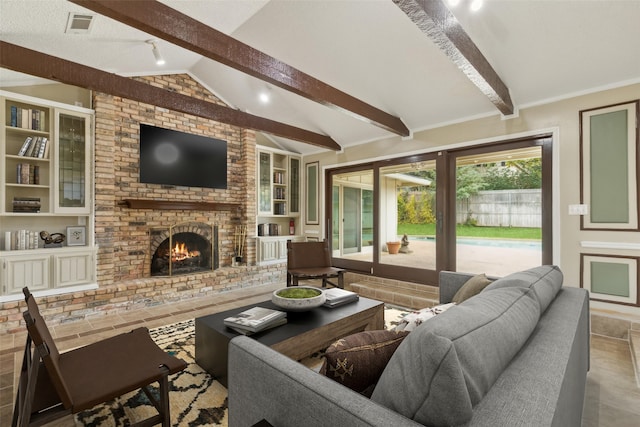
[371,287,540,425]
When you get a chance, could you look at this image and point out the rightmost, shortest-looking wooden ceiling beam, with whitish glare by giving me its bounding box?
[393,0,514,116]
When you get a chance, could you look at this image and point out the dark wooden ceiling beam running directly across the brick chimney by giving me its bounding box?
[0,41,342,151]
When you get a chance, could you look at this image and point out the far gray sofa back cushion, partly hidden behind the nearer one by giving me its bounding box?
[484,265,563,313]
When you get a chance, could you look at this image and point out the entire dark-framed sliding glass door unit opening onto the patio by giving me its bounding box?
[326,137,552,284]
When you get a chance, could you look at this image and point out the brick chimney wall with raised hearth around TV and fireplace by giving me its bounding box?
[0,74,286,332]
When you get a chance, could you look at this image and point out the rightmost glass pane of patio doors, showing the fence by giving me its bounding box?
[456,146,542,276]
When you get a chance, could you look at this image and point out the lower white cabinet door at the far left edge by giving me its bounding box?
[1,255,51,294]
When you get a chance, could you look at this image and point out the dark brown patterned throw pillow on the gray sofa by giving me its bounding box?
[320,330,408,397]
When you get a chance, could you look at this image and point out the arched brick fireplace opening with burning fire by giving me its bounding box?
[150,223,219,276]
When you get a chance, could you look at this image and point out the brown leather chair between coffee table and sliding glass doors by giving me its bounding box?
[287,240,346,288]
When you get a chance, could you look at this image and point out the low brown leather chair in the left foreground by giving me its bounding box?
[11,288,187,427]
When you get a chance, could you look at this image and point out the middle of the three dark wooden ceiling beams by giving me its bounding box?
[69,0,410,136]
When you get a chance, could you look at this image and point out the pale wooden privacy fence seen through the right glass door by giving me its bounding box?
[456,189,542,228]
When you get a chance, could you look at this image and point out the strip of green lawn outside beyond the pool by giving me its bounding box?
[398,224,542,240]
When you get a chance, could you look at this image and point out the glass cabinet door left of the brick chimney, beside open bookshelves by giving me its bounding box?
[55,111,91,213]
